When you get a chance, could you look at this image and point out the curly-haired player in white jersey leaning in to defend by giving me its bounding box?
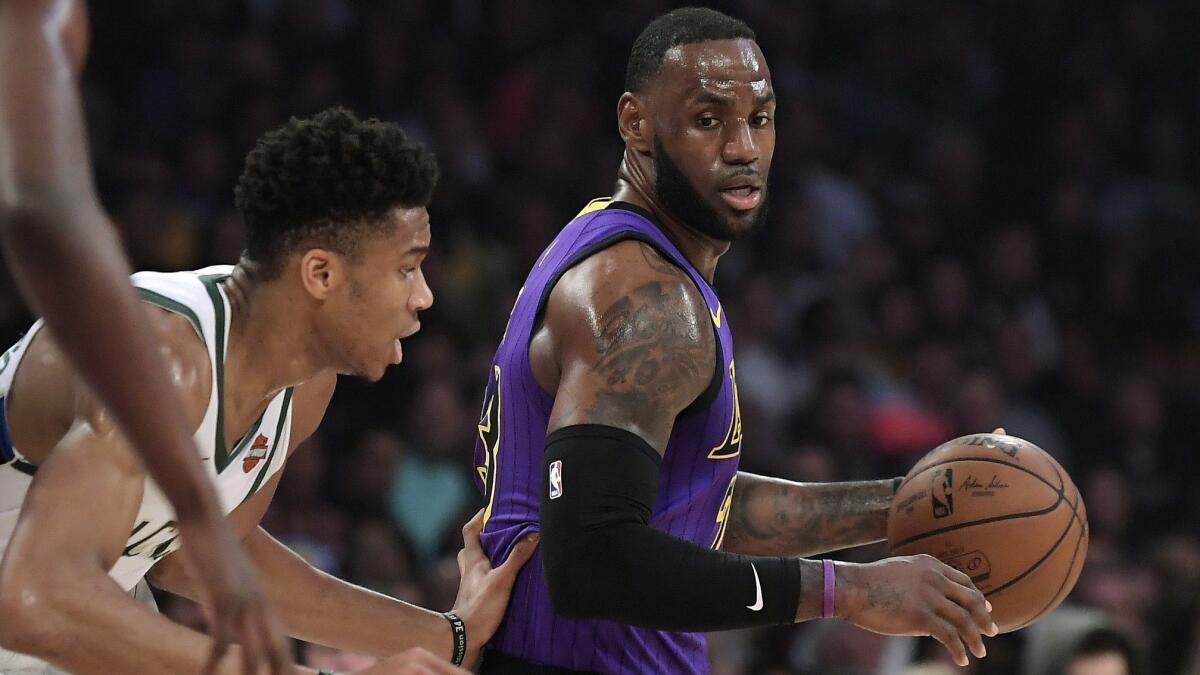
[0,109,534,675]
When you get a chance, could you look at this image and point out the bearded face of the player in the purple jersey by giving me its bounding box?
[646,40,775,241]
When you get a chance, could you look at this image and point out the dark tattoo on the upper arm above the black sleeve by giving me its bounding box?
[592,275,713,437]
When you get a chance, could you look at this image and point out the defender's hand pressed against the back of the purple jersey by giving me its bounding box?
[451,510,539,664]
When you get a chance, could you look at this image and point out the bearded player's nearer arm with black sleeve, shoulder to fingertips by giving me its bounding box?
[541,243,991,662]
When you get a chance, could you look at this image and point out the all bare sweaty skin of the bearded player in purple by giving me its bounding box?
[529,40,996,664]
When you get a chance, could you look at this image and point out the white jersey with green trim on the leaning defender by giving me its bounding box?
[0,265,292,590]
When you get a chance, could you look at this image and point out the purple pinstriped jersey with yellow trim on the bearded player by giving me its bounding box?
[475,199,742,675]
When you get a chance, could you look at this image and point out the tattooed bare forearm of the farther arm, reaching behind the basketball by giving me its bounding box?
[721,472,894,557]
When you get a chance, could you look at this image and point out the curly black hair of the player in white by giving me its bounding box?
[234,107,438,280]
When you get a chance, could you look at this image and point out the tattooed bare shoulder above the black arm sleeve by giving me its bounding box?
[545,241,716,452]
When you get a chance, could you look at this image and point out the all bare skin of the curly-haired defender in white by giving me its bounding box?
[0,186,535,675]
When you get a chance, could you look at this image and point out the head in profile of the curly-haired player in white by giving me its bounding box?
[234,108,438,380]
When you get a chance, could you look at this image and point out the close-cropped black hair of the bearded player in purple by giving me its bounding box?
[625,7,758,91]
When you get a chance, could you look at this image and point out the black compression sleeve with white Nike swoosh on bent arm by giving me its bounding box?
[541,424,800,631]
